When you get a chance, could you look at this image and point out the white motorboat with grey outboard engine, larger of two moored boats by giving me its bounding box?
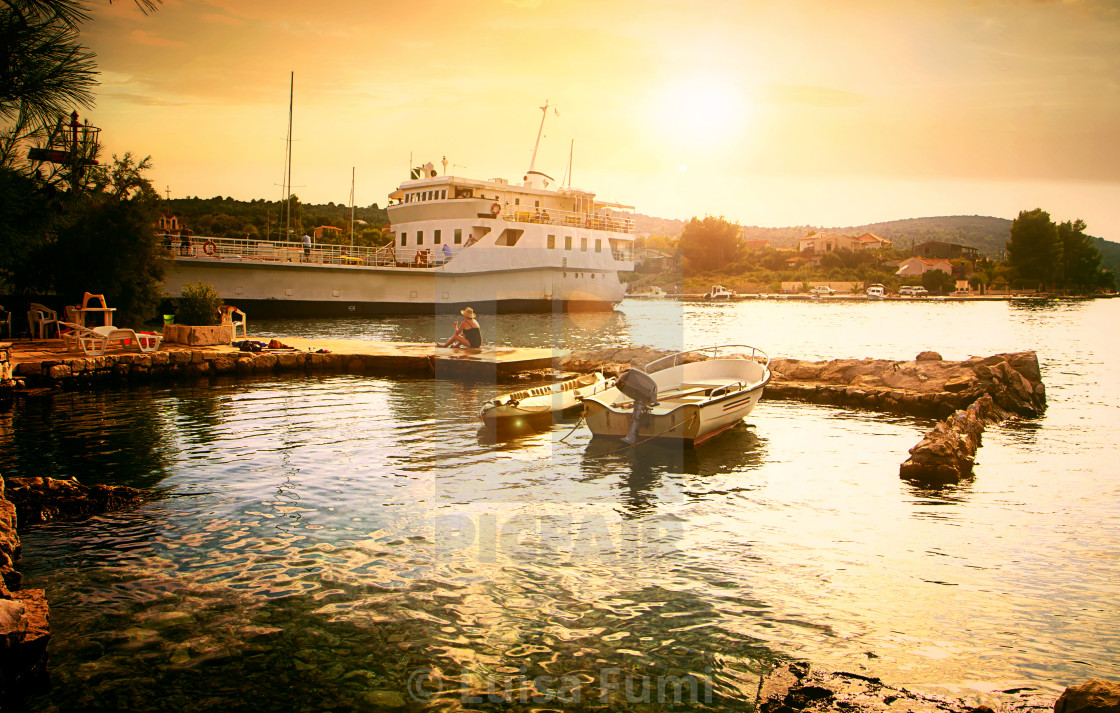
[584,345,771,445]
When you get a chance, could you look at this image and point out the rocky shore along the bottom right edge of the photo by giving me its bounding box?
[756,662,1120,713]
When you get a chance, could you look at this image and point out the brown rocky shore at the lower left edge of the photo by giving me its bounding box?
[0,478,143,701]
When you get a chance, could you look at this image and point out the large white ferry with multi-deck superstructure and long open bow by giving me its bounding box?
[164,104,634,318]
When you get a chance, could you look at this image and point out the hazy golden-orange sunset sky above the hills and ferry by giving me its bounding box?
[83,0,1120,241]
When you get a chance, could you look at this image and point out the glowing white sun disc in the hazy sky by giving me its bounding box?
[651,77,748,146]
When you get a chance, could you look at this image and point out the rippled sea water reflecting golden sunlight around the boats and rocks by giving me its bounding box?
[0,299,1120,712]
